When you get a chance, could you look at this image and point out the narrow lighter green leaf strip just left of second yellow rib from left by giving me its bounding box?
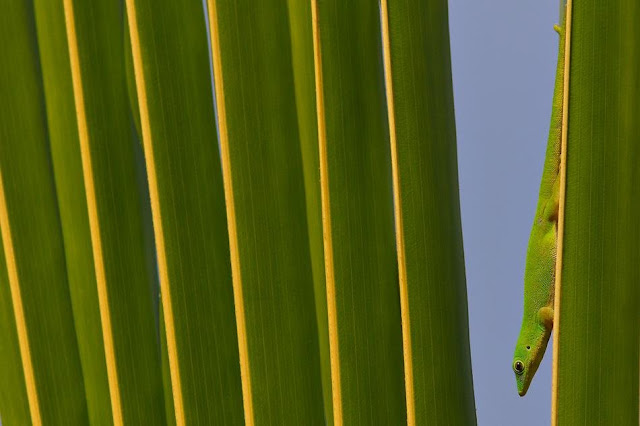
[34,0,113,425]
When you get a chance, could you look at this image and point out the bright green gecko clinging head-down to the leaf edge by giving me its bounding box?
[513,11,566,396]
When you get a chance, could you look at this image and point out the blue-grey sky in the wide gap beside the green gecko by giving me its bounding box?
[449,0,559,426]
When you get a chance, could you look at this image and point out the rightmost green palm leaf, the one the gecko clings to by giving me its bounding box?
[552,0,640,425]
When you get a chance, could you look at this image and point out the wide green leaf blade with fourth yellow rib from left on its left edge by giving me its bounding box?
[209,0,325,425]
